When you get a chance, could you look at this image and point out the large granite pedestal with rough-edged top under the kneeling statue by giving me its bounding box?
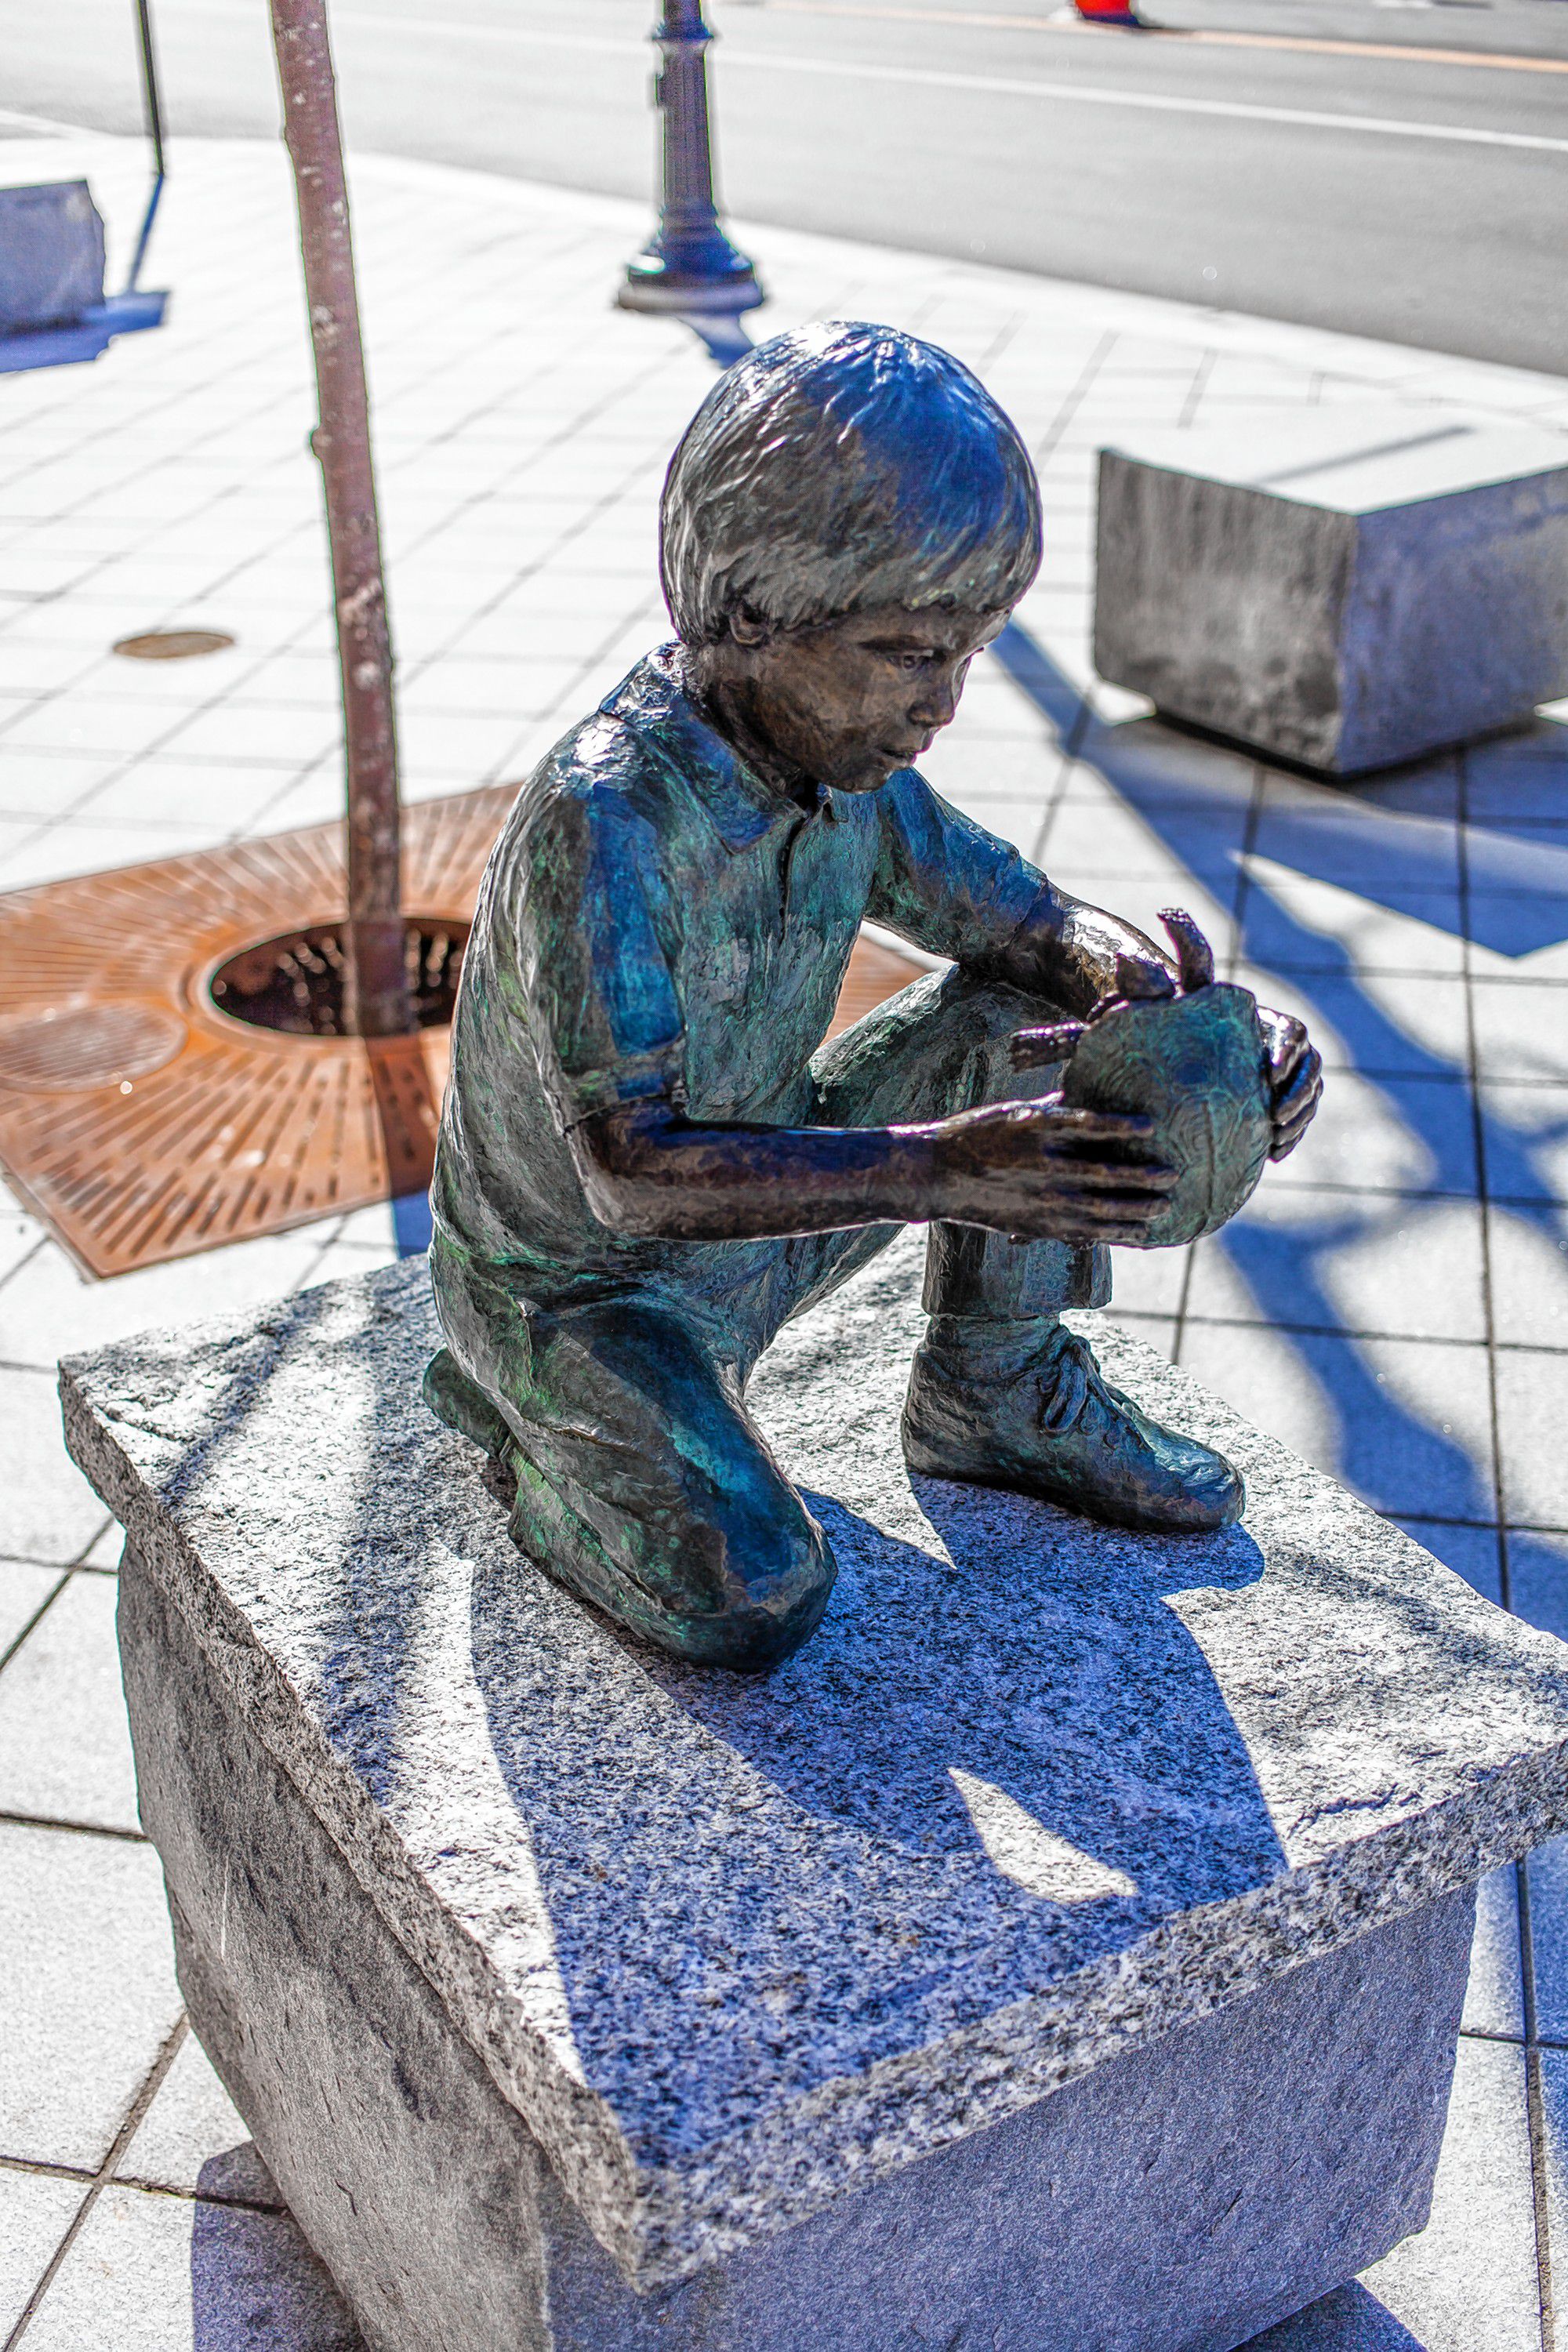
[61,1242,1568,2352]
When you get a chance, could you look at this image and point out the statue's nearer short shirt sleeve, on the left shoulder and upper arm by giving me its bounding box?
[513,793,684,1129]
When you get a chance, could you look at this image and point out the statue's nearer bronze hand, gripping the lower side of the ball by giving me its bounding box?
[931,1094,1175,1247]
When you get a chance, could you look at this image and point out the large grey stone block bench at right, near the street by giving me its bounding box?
[1093,409,1568,776]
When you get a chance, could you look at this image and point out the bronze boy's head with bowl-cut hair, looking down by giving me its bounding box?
[661,322,1039,790]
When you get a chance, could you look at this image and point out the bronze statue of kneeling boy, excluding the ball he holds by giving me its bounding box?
[426,325,1319,1668]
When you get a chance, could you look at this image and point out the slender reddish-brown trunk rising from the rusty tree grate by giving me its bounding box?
[270,0,414,1037]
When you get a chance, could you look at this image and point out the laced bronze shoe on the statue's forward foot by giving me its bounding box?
[902,1315,1246,1536]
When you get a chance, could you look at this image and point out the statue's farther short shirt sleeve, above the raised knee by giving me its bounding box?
[865,767,1048,964]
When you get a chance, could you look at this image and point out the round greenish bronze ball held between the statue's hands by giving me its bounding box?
[1062,981,1272,1249]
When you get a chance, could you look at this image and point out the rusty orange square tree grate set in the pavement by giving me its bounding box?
[0,783,916,1275]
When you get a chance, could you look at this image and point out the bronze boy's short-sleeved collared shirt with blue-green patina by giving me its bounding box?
[433,647,1046,1305]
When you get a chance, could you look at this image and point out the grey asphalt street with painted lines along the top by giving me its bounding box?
[0,0,1568,374]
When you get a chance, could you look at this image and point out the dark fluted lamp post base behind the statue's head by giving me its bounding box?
[616,0,764,318]
